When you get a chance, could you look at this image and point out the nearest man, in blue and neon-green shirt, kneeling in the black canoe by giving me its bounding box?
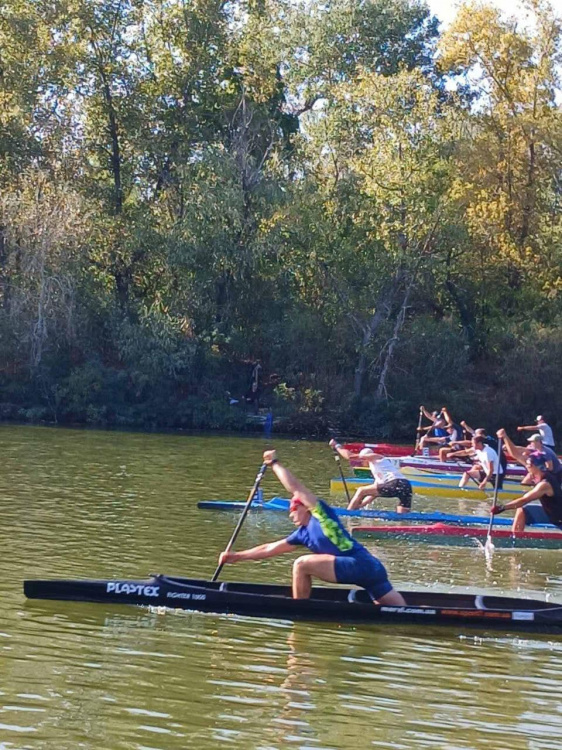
[219,451,405,606]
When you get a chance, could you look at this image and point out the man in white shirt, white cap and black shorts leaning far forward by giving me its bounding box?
[329,440,412,513]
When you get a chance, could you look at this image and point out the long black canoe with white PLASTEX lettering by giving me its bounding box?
[24,575,562,634]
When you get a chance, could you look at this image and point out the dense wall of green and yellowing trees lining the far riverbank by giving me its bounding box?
[0,0,562,437]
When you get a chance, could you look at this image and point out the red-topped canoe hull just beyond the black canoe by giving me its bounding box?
[351,523,562,549]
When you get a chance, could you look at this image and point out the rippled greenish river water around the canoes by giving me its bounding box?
[0,426,562,750]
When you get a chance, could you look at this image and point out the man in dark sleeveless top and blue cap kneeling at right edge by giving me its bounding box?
[490,453,562,532]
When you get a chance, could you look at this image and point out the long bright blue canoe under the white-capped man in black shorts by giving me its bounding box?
[197,497,554,529]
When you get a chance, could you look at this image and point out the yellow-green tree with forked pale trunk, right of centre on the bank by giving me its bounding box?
[270,66,457,396]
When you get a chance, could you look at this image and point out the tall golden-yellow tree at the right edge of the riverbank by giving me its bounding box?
[440,0,562,326]
